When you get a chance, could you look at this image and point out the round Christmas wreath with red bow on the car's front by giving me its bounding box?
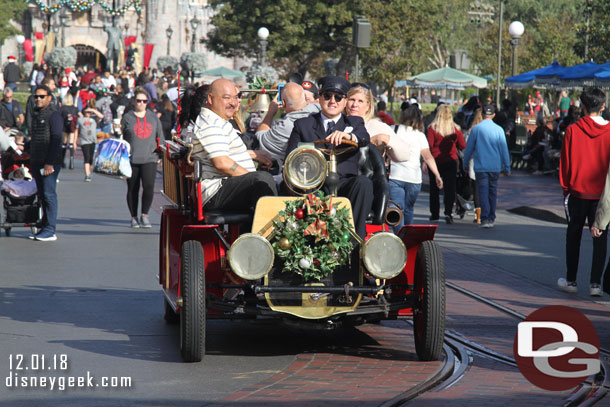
[272,191,352,282]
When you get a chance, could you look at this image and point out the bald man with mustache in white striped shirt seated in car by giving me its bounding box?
[193,79,277,214]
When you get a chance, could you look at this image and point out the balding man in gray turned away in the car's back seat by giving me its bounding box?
[256,82,320,167]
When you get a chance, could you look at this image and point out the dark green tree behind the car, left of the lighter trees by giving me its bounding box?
[204,0,362,73]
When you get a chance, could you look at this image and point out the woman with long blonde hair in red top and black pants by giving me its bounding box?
[426,105,466,223]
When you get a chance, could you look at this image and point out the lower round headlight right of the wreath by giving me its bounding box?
[362,232,407,279]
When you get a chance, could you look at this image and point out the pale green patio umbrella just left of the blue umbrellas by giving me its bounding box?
[396,67,487,89]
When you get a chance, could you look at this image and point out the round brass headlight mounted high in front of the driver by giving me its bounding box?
[284,147,327,192]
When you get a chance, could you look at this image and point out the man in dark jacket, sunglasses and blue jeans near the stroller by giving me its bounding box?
[30,85,64,242]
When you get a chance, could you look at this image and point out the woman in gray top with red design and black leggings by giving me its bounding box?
[121,88,165,228]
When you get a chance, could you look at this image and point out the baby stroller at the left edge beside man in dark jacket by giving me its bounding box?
[0,153,43,236]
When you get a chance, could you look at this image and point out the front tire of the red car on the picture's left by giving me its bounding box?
[180,240,206,363]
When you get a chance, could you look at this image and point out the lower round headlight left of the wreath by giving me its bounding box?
[228,233,275,280]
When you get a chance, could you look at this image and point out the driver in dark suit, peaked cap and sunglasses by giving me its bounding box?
[286,76,373,239]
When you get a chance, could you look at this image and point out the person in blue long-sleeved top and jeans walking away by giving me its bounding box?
[464,105,510,229]
